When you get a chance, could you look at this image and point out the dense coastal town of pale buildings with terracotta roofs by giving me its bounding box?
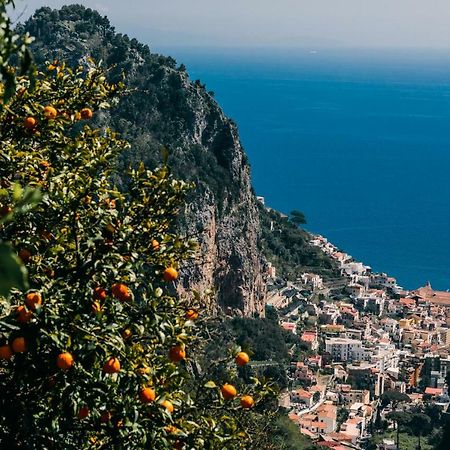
[268,230,450,450]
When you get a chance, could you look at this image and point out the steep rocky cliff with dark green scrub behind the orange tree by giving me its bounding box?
[24,6,266,315]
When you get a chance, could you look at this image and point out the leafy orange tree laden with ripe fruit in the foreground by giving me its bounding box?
[0,62,269,449]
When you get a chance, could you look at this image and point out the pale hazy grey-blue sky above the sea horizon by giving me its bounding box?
[10,0,450,49]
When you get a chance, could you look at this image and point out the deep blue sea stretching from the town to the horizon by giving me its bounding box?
[159,48,450,290]
